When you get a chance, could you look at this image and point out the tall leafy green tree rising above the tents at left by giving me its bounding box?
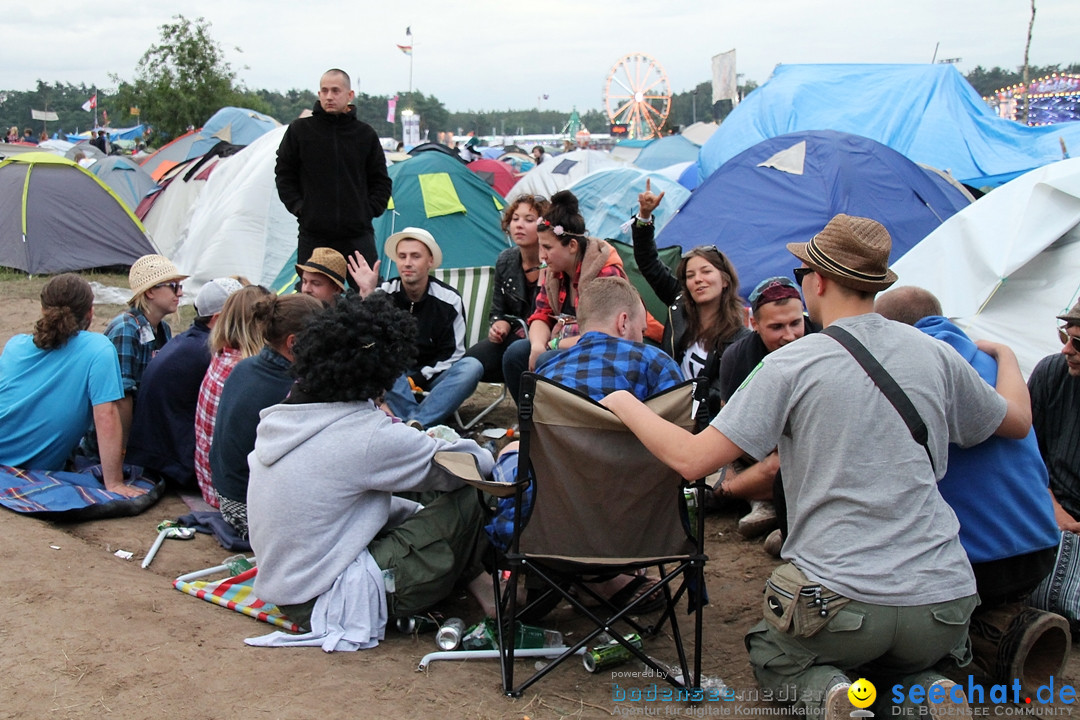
[112,15,252,137]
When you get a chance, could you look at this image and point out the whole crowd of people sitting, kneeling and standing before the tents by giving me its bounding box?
[0,70,1080,718]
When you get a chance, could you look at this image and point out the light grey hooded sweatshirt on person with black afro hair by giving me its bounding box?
[247,400,494,604]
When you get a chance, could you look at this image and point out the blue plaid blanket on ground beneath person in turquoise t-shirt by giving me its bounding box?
[0,465,165,520]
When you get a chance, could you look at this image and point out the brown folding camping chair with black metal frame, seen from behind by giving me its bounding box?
[436,372,707,697]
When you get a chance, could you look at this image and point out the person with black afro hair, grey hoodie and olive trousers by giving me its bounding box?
[247,295,494,651]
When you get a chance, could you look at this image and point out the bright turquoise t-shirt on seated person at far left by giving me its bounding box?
[0,331,124,470]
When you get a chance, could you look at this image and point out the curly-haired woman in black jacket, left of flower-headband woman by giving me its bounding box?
[465,195,548,382]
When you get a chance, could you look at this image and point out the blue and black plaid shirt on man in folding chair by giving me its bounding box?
[484,331,683,549]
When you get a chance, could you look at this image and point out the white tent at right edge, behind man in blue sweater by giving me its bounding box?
[893,158,1080,375]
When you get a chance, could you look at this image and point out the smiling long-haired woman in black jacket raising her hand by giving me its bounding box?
[632,180,751,416]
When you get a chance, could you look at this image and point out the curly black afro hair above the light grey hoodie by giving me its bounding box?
[293,293,416,403]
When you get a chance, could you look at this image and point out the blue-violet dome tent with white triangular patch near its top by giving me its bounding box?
[657,131,970,297]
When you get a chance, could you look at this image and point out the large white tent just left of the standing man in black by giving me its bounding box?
[173,126,297,297]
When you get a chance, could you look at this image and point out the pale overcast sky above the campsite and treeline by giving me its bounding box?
[0,0,1080,111]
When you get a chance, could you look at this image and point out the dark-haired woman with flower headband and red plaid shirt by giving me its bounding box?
[502,190,660,402]
